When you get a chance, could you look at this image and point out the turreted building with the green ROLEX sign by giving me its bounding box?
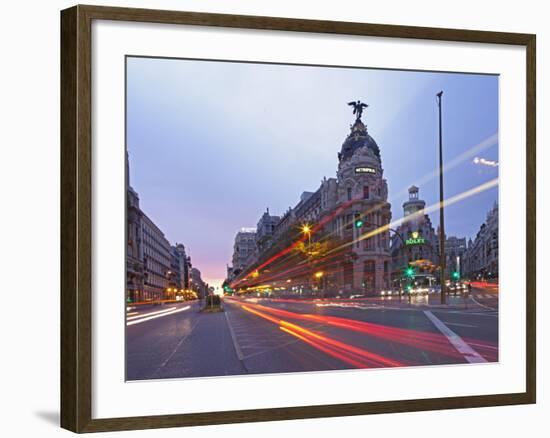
[391,186,439,287]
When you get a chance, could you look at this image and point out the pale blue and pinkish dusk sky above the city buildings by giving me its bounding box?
[127,58,498,286]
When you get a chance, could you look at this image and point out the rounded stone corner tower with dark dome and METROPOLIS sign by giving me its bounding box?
[320,106,391,295]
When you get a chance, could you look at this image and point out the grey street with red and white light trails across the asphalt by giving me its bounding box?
[126,289,498,380]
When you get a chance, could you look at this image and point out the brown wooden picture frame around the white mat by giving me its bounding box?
[61,6,536,432]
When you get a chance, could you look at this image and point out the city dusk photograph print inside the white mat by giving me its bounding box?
[124,56,499,381]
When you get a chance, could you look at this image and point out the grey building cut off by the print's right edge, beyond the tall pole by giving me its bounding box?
[464,202,499,279]
